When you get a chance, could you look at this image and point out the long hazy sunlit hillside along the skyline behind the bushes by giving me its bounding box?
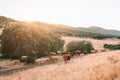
[0,16,120,39]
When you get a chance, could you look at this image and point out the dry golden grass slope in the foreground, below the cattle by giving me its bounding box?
[0,50,120,80]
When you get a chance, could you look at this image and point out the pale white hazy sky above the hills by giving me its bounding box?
[0,0,120,30]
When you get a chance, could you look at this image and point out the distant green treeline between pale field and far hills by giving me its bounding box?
[56,30,120,39]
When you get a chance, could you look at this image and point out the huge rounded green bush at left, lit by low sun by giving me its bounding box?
[0,24,64,62]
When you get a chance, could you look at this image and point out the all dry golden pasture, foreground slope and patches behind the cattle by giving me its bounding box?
[0,37,120,80]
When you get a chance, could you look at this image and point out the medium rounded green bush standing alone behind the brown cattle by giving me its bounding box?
[67,41,94,54]
